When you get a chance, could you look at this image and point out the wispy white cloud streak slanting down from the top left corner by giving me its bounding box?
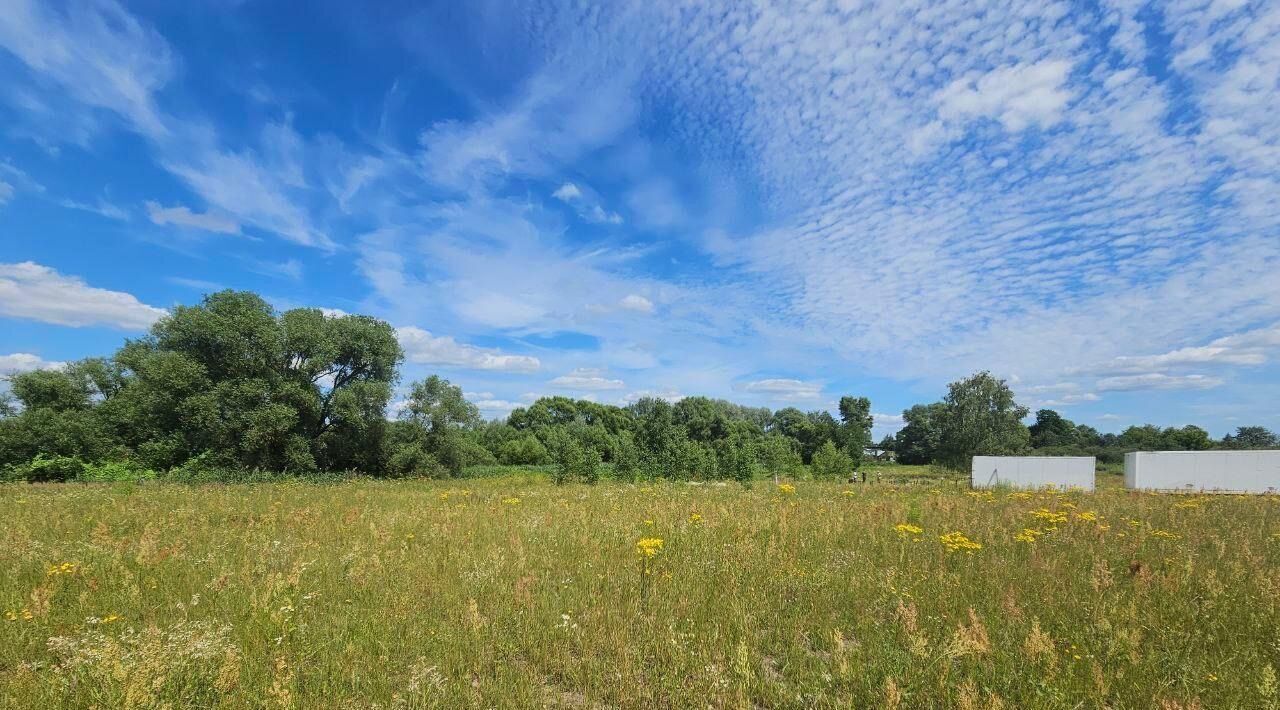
[0,0,333,248]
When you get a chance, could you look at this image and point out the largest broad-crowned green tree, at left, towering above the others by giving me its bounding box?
[113,290,402,472]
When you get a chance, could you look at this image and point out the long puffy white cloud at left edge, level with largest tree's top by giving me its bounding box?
[0,261,165,330]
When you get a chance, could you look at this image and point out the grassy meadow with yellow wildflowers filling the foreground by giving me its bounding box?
[0,473,1280,709]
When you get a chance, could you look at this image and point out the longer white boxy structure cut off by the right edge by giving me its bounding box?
[1124,450,1280,493]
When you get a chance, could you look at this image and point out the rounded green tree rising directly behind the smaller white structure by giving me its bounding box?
[938,372,1030,469]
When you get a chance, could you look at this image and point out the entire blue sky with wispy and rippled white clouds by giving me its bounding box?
[0,0,1280,436]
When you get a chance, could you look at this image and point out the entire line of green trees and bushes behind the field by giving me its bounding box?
[0,290,1276,482]
